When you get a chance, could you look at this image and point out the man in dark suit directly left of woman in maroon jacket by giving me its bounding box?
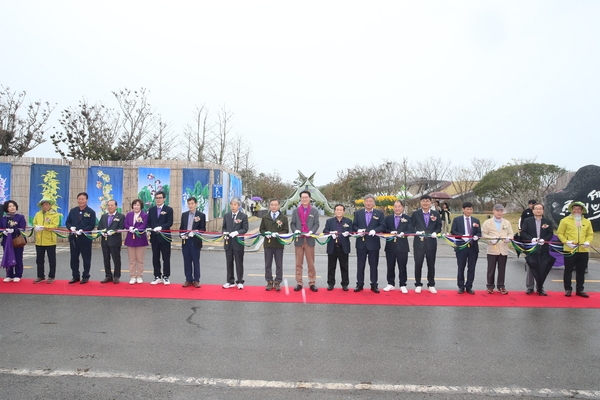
[98,200,125,283]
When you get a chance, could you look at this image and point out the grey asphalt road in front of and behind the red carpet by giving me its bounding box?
[0,217,600,399]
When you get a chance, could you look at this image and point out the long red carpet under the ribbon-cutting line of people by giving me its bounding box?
[0,279,600,308]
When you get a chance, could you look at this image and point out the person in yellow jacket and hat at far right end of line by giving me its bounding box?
[556,201,594,297]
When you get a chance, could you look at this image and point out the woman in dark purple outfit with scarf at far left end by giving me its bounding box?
[0,200,27,282]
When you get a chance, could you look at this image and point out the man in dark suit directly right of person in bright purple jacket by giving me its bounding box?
[179,197,206,288]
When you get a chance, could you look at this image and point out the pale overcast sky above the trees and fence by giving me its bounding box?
[0,0,600,184]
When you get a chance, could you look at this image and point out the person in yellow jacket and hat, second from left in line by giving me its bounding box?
[33,199,60,283]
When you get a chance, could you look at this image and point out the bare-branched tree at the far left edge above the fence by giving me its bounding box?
[0,85,54,157]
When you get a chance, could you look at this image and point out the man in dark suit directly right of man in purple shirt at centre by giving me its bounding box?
[323,204,352,292]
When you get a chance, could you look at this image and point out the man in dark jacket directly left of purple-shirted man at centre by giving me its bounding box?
[259,199,290,292]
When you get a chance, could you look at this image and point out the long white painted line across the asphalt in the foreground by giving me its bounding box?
[0,368,600,399]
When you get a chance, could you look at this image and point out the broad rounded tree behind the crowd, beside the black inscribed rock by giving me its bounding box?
[473,163,565,208]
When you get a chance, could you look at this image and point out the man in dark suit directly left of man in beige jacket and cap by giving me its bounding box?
[450,201,481,294]
